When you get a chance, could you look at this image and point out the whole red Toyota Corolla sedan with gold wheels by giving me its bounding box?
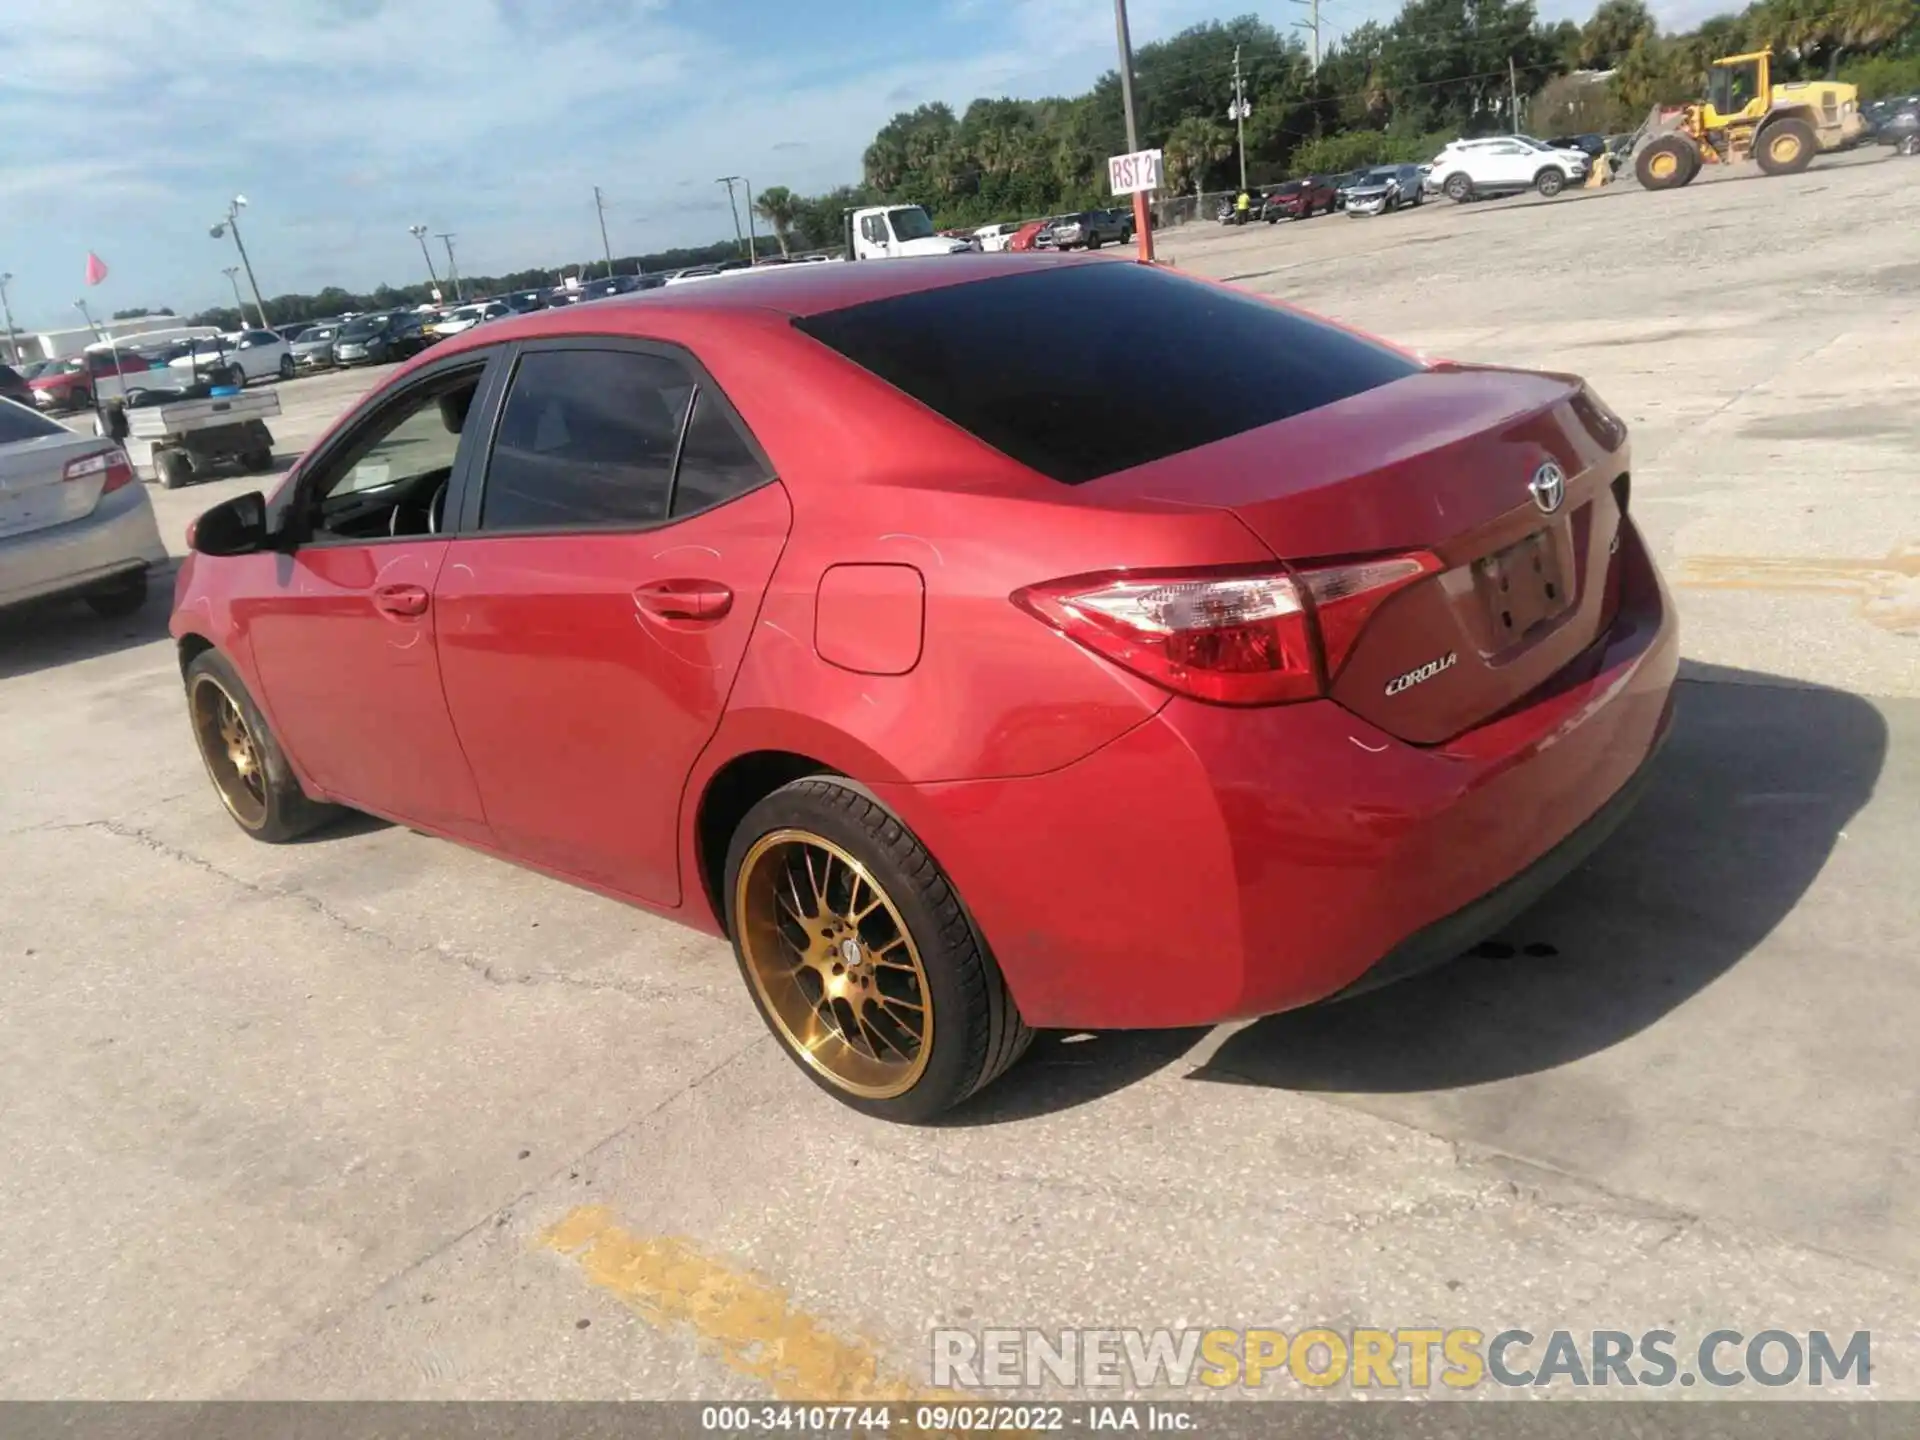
[173,255,1676,1119]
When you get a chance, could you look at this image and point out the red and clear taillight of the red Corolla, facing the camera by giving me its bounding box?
[1012,553,1440,705]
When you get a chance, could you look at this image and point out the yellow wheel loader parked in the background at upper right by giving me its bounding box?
[1634,50,1866,190]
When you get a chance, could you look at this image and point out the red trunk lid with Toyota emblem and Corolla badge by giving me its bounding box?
[1110,367,1626,745]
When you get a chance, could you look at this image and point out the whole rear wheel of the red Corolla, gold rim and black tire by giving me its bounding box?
[726,776,1033,1123]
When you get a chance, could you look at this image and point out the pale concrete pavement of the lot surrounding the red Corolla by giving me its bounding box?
[0,156,1920,1398]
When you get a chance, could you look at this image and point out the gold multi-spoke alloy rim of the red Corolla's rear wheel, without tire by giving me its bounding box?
[733,829,933,1100]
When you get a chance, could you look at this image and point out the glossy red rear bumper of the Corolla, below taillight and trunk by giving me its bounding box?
[874,532,1678,1029]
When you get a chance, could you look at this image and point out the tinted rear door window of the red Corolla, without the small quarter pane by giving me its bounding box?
[480,349,693,530]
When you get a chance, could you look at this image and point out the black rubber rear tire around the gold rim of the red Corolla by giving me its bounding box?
[726,776,1033,1123]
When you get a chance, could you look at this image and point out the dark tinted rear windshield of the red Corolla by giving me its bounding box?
[795,261,1419,486]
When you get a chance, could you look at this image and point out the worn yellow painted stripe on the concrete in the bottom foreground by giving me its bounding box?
[540,1206,937,1402]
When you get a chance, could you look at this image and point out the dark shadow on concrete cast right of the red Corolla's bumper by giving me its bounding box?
[1190,664,1887,1094]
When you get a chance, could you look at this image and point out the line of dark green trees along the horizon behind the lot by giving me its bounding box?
[194,0,1920,324]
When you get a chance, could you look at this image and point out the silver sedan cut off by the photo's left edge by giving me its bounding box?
[0,399,167,616]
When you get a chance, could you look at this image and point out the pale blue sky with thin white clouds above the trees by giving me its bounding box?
[0,0,1643,328]
